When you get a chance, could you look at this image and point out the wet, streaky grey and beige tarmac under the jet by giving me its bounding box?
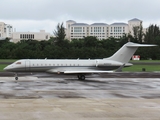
[0,72,160,120]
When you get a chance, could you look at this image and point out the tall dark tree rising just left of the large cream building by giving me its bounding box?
[53,23,66,46]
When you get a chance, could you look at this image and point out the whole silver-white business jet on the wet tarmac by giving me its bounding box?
[4,42,156,80]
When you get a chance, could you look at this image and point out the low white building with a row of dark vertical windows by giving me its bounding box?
[12,30,51,43]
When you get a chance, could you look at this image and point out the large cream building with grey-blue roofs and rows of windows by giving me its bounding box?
[66,18,142,40]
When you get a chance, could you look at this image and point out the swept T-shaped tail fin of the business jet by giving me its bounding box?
[104,42,156,64]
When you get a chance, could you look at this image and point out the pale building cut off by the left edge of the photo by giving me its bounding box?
[0,22,13,38]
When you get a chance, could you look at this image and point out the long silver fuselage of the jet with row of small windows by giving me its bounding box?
[4,59,126,73]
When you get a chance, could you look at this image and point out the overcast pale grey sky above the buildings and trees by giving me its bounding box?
[0,0,160,34]
